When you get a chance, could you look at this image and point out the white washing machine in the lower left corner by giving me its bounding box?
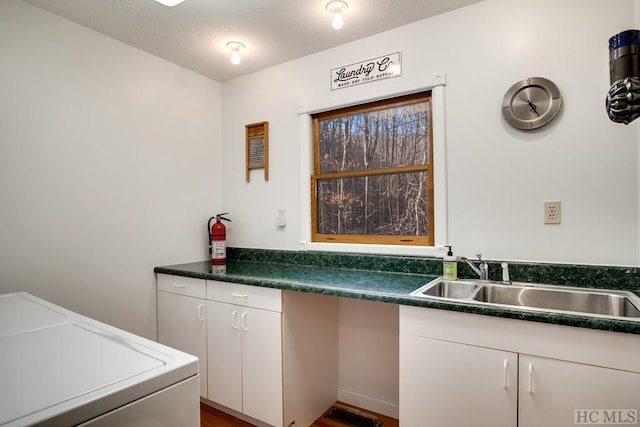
[0,292,200,427]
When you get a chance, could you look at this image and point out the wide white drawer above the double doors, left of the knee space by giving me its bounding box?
[207,280,282,312]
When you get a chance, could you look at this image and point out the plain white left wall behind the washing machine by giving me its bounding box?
[0,0,221,338]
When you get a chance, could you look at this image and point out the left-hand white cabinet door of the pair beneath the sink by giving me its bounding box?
[400,334,520,427]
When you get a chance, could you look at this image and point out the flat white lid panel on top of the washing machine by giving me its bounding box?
[0,323,164,424]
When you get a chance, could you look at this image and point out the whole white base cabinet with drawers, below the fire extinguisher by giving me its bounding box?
[157,274,339,427]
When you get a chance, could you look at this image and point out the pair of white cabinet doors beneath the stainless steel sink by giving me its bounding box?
[400,335,640,427]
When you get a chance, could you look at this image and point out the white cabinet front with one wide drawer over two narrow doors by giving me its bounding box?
[207,281,283,426]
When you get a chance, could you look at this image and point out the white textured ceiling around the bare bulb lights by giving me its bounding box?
[23,0,481,82]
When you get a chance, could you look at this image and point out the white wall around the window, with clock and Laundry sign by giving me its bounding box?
[222,0,639,265]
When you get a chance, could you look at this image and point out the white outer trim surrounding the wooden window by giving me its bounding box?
[298,73,449,257]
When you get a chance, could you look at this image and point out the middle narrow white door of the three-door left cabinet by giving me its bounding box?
[207,301,243,412]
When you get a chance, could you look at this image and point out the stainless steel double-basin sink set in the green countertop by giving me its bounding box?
[411,277,640,321]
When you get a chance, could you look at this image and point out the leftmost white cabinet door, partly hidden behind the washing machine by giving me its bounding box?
[158,291,207,398]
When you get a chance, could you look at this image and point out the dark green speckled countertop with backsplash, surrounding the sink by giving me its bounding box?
[154,250,640,334]
